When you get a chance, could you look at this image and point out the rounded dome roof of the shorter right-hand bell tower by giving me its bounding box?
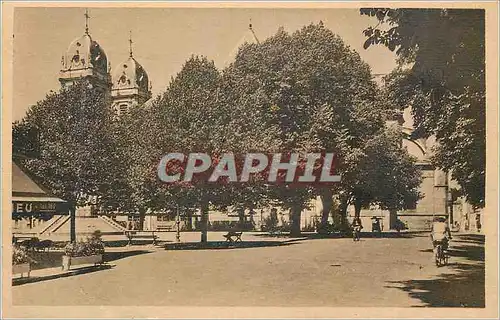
[113,56,149,92]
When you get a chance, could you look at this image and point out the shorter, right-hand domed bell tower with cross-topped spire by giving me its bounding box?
[111,31,151,116]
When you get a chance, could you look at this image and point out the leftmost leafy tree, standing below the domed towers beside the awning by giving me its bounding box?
[13,81,119,241]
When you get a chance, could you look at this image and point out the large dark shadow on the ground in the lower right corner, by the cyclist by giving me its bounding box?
[388,235,485,308]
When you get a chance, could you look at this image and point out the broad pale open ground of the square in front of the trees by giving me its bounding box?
[13,233,484,307]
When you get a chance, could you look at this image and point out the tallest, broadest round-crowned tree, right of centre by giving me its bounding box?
[228,23,383,235]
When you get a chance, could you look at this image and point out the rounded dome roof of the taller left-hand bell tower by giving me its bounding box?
[62,33,108,74]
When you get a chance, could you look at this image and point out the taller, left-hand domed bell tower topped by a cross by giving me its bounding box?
[59,10,111,92]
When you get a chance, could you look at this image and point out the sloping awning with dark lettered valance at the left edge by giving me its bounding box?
[12,161,69,218]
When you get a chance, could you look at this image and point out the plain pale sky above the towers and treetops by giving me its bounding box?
[12,8,396,121]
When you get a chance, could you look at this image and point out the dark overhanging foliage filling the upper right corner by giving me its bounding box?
[361,8,486,207]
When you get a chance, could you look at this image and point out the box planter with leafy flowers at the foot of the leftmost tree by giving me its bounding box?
[62,231,104,270]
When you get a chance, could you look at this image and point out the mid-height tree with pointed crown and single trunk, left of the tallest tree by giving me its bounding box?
[151,57,280,242]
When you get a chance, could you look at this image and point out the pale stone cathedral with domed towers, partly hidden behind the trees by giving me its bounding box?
[13,12,480,234]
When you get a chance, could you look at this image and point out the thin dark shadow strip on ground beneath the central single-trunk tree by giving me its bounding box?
[165,238,304,250]
